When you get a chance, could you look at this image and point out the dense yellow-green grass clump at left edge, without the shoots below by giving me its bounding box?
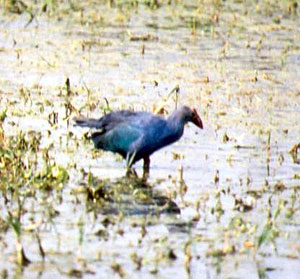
[0,130,69,195]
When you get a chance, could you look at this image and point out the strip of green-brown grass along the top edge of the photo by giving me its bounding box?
[0,0,300,32]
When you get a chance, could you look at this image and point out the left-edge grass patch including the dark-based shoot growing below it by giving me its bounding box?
[0,124,69,266]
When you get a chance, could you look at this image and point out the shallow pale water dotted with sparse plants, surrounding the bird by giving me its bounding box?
[0,3,300,278]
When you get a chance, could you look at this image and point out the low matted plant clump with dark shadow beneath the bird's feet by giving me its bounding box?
[78,172,180,216]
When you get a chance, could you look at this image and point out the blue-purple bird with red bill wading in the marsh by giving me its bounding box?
[74,106,203,175]
